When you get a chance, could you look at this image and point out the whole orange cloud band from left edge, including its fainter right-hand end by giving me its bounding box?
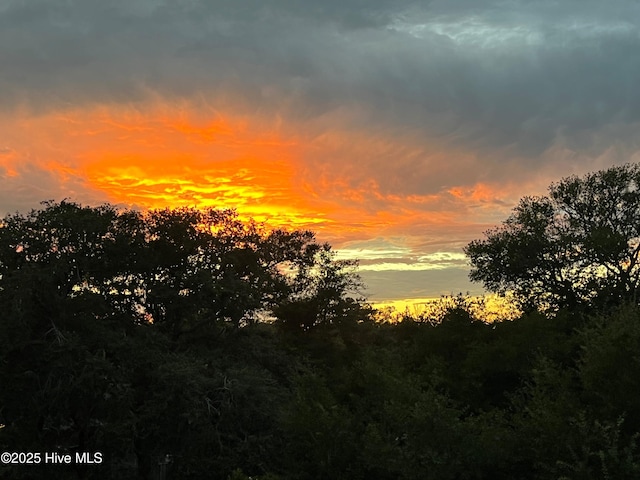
[0,99,516,255]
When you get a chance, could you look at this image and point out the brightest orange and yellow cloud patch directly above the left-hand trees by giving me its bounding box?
[0,105,323,226]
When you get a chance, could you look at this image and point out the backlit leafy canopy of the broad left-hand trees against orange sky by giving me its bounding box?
[0,201,359,336]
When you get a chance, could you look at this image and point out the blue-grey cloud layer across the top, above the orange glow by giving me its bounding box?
[0,0,640,152]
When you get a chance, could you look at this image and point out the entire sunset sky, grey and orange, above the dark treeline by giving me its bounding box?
[0,0,640,302]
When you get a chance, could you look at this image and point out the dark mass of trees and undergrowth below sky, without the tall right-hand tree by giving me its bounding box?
[0,164,640,480]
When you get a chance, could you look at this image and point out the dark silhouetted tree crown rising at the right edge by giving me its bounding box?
[465,164,640,310]
